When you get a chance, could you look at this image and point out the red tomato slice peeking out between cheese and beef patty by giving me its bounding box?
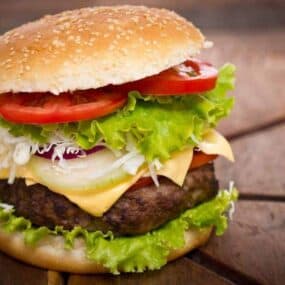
[128,151,217,191]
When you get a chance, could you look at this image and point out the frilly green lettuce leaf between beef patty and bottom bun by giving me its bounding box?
[0,186,238,274]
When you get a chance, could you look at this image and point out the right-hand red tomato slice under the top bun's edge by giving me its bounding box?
[113,59,218,96]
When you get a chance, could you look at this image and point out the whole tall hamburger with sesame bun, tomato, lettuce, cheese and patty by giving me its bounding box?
[0,6,237,274]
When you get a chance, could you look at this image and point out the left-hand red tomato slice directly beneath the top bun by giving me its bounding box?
[0,90,128,124]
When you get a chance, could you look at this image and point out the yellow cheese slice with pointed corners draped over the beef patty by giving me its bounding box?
[0,130,234,216]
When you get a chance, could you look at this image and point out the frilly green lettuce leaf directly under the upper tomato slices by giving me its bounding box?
[0,64,235,161]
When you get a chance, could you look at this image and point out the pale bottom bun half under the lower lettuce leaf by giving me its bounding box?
[0,225,211,274]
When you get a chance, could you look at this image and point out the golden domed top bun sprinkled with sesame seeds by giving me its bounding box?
[0,6,204,94]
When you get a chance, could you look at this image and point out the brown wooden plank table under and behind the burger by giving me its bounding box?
[0,1,285,285]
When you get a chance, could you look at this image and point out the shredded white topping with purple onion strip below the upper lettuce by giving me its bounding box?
[0,128,149,182]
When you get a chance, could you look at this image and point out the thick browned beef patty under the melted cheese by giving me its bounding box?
[0,164,218,235]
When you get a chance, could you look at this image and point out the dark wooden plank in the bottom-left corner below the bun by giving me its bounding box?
[0,252,48,285]
